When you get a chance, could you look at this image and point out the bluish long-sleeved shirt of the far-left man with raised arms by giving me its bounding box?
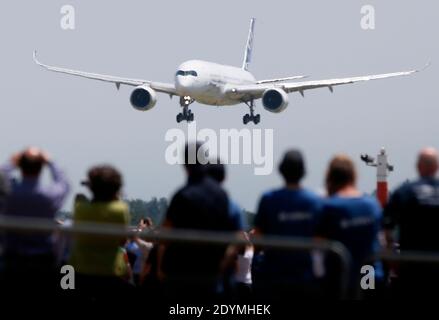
[1,163,69,255]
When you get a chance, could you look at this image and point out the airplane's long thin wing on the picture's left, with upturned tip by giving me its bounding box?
[34,51,178,95]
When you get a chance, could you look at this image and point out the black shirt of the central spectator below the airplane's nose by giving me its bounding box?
[162,177,239,277]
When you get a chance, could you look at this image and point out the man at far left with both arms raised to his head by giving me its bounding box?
[0,147,69,289]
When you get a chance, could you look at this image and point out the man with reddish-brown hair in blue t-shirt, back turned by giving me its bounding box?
[316,155,383,298]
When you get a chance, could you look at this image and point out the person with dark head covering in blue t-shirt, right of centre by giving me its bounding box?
[253,150,321,299]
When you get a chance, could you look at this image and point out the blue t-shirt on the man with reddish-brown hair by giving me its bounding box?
[316,196,382,283]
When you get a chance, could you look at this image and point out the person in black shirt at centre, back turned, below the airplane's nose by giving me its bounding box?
[158,145,240,300]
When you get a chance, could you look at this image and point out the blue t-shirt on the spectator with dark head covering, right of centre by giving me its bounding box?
[255,188,321,282]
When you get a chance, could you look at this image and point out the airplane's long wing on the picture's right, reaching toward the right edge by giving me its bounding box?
[226,64,429,101]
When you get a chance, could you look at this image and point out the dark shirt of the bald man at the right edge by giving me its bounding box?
[384,178,439,251]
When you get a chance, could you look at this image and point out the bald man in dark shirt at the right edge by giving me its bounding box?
[384,148,439,295]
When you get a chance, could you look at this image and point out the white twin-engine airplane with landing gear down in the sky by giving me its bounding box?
[33,18,428,125]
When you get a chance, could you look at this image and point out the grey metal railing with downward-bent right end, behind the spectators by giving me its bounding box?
[0,216,351,299]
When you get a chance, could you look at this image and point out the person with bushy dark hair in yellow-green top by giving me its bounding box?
[70,165,130,299]
